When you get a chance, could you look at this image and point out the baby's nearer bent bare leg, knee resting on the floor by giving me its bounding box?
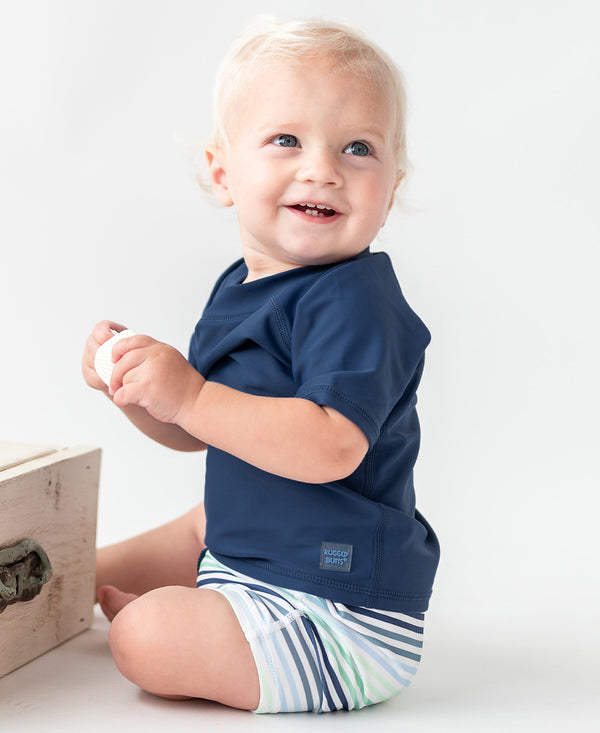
[109,587,260,710]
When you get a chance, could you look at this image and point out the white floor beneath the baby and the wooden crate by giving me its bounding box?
[0,613,600,733]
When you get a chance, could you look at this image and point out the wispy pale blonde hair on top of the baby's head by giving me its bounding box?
[211,16,408,175]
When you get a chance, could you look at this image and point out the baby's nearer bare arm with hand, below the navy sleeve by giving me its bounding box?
[111,336,368,483]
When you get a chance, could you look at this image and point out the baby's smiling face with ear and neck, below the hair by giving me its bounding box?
[211,60,397,279]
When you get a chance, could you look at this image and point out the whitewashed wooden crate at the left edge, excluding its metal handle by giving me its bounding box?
[0,441,100,677]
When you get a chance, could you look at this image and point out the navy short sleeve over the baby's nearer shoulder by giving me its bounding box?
[292,254,430,446]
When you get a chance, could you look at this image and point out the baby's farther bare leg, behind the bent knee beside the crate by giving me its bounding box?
[96,504,206,595]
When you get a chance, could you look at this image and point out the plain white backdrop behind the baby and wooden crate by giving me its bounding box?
[0,0,600,688]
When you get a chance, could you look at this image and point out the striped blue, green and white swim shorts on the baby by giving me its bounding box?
[197,551,424,713]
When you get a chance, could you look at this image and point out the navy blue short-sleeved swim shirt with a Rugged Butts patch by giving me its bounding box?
[189,249,439,613]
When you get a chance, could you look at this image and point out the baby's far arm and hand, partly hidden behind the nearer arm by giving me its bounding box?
[82,321,206,451]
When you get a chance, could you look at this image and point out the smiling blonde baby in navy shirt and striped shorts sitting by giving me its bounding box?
[83,21,439,713]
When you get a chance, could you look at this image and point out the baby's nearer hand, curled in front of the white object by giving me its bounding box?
[110,335,205,423]
